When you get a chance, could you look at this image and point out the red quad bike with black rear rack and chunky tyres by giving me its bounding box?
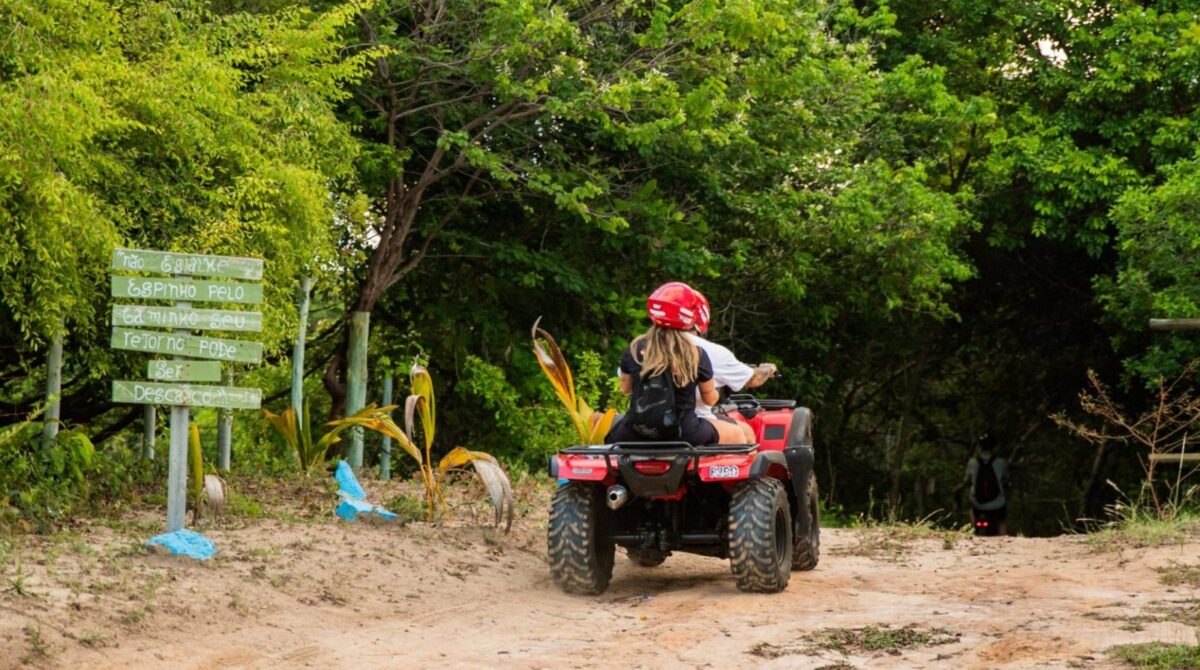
[548,394,821,593]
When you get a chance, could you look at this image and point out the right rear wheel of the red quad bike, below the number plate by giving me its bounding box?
[730,477,792,593]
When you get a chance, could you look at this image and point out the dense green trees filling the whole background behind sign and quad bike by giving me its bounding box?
[0,0,1200,532]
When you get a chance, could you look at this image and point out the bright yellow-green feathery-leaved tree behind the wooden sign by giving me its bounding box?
[0,0,370,432]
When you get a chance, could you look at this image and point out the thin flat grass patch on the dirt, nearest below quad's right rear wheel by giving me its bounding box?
[746,626,959,658]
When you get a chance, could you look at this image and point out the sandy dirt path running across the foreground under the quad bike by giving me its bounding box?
[0,497,1200,670]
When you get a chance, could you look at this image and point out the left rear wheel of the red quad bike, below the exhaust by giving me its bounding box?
[547,483,617,594]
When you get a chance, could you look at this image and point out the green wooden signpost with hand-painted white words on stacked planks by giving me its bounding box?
[110,249,263,533]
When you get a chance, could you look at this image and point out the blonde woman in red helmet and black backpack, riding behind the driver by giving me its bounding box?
[605,282,752,445]
